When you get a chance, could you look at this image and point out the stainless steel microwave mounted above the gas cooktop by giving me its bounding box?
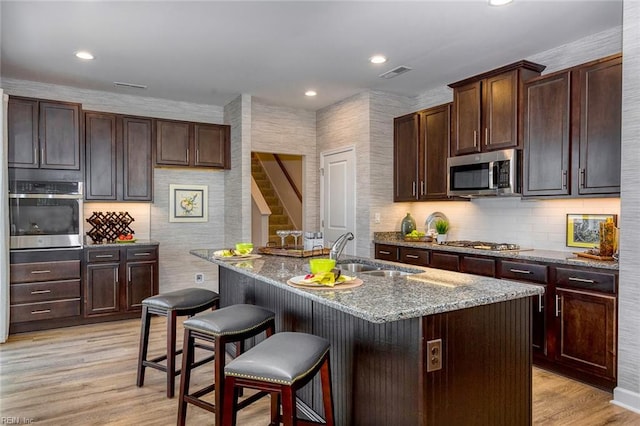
[447,149,521,197]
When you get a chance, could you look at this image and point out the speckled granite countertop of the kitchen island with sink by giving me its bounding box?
[190,249,544,323]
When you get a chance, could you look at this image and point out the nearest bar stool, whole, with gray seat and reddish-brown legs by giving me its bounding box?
[221,332,334,426]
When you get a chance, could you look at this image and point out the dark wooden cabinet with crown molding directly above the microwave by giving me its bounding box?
[449,61,545,156]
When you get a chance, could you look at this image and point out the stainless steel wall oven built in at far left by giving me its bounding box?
[9,180,83,249]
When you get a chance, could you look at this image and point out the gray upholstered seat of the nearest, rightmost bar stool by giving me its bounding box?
[224,333,331,385]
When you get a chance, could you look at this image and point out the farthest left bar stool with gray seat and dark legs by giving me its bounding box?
[136,288,220,398]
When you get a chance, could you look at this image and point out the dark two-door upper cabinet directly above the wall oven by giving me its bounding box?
[7,97,81,170]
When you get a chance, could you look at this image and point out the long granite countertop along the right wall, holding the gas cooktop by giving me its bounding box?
[373,232,619,270]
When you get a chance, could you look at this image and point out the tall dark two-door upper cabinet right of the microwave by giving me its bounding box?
[523,55,622,197]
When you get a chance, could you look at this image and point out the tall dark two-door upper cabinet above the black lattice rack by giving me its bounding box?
[84,112,153,201]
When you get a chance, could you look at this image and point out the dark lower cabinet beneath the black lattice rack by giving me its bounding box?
[84,245,158,317]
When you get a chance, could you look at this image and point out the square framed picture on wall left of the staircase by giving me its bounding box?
[169,184,208,222]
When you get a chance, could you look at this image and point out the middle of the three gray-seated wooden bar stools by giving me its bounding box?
[178,304,275,426]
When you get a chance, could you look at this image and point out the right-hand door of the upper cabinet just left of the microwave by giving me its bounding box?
[419,104,451,200]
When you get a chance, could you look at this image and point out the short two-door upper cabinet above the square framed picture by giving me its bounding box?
[155,120,231,169]
